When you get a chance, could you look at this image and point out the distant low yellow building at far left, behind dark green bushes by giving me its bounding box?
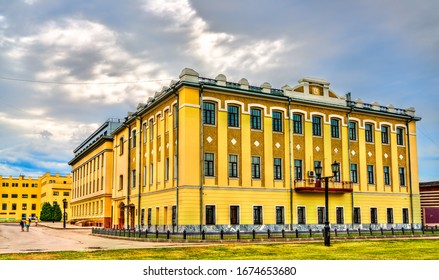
[0,173,72,221]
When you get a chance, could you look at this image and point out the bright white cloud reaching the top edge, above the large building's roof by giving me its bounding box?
[144,0,294,72]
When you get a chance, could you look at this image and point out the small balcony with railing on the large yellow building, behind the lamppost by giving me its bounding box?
[294,179,352,193]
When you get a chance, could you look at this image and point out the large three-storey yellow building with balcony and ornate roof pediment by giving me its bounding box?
[77,68,421,231]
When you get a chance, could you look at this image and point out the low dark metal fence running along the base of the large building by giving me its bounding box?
[92,226,439,241]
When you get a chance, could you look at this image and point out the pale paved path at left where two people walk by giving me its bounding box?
[0,223,208,254]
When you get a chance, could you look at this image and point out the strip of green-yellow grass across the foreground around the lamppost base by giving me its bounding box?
[0,239,439,260]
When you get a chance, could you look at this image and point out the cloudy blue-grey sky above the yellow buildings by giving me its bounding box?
[0,0,439,182]
